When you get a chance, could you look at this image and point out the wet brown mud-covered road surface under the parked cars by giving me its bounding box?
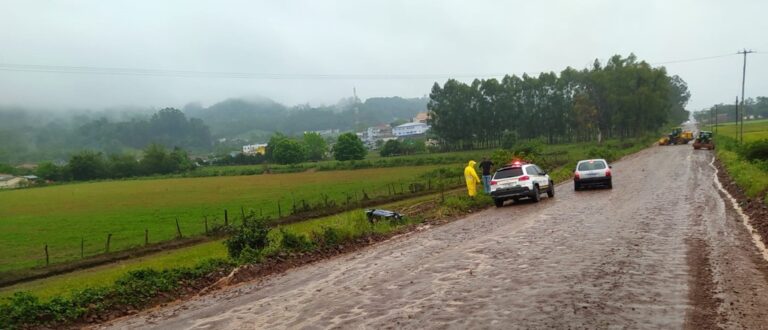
[103,145,768,329]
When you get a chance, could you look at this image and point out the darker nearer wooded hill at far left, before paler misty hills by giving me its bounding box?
[0,107,213,163]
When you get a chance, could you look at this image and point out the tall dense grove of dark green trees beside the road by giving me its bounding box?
[427,54,690,149]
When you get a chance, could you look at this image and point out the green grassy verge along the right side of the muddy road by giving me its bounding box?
[702,120,768,204]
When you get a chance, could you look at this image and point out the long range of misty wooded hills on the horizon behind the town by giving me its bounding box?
[0,97,427,164]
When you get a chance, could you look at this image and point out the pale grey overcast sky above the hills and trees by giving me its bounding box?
[0,0,768,110]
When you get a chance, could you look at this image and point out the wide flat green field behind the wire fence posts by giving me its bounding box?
[0,166,444,272]
